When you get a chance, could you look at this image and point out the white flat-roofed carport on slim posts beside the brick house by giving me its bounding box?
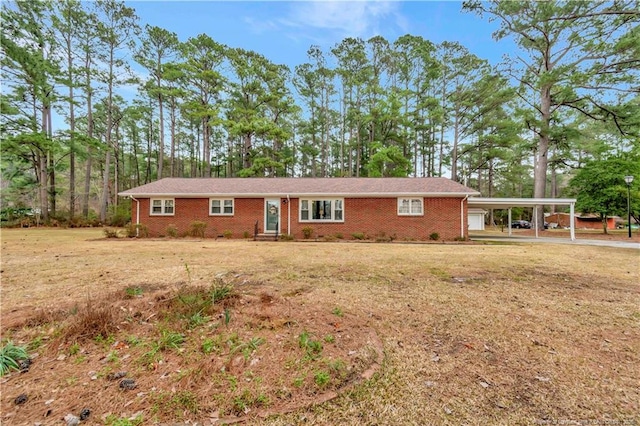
[467,197,576,241]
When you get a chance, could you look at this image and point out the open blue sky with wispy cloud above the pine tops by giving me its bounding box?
[127,0,513,69]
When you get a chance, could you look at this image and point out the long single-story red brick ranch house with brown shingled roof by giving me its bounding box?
[118,178,479,240]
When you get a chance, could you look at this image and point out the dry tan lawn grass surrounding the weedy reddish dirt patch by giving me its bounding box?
[1,230,640,425]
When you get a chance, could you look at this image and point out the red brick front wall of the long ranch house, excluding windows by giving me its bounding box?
[132,198,468,240]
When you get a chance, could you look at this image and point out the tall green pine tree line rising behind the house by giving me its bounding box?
[0,0,640,223]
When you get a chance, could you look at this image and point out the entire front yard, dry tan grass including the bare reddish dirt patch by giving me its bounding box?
[0,230,640,425]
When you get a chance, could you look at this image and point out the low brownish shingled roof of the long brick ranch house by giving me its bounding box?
[118,177,480,198]
